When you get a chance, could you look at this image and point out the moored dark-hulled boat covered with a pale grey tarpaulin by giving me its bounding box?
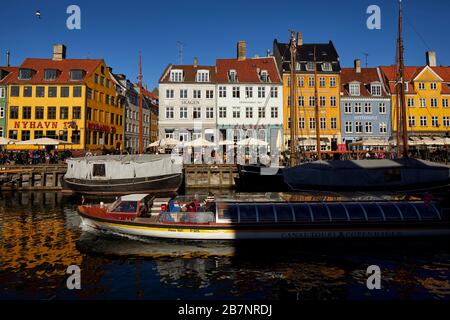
[62,154,183,195]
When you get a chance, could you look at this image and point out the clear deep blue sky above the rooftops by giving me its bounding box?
[0,0,450,88]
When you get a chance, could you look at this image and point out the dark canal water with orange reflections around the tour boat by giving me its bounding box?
[0,193,450,300]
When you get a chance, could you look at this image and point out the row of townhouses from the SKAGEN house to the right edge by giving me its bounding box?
[159,33,450,150]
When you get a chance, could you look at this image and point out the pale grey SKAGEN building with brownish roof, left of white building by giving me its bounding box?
[158,59,216,141]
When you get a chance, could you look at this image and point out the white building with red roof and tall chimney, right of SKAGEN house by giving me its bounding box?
[216,41,283,145]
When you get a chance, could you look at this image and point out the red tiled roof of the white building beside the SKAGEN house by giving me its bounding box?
[216,57,281,83]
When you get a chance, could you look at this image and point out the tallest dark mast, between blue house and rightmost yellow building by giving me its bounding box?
[397,0,408,157]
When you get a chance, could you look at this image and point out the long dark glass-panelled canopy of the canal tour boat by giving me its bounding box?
[218,202,442,223]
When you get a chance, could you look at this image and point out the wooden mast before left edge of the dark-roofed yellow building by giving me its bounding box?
[290,31,298,167]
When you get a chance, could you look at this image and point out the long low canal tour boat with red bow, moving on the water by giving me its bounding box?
[79,194,450,240]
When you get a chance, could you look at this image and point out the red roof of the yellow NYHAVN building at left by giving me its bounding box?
[2,58,104,84]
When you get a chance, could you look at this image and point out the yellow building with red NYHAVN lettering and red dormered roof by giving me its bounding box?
[4,45,124,151]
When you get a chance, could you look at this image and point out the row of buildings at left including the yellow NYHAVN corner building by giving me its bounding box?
[0,44,158,152]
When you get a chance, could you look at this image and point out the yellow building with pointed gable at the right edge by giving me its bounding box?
[381,53,450,137]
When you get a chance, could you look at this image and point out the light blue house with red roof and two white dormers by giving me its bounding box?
[340,60,392,148]
